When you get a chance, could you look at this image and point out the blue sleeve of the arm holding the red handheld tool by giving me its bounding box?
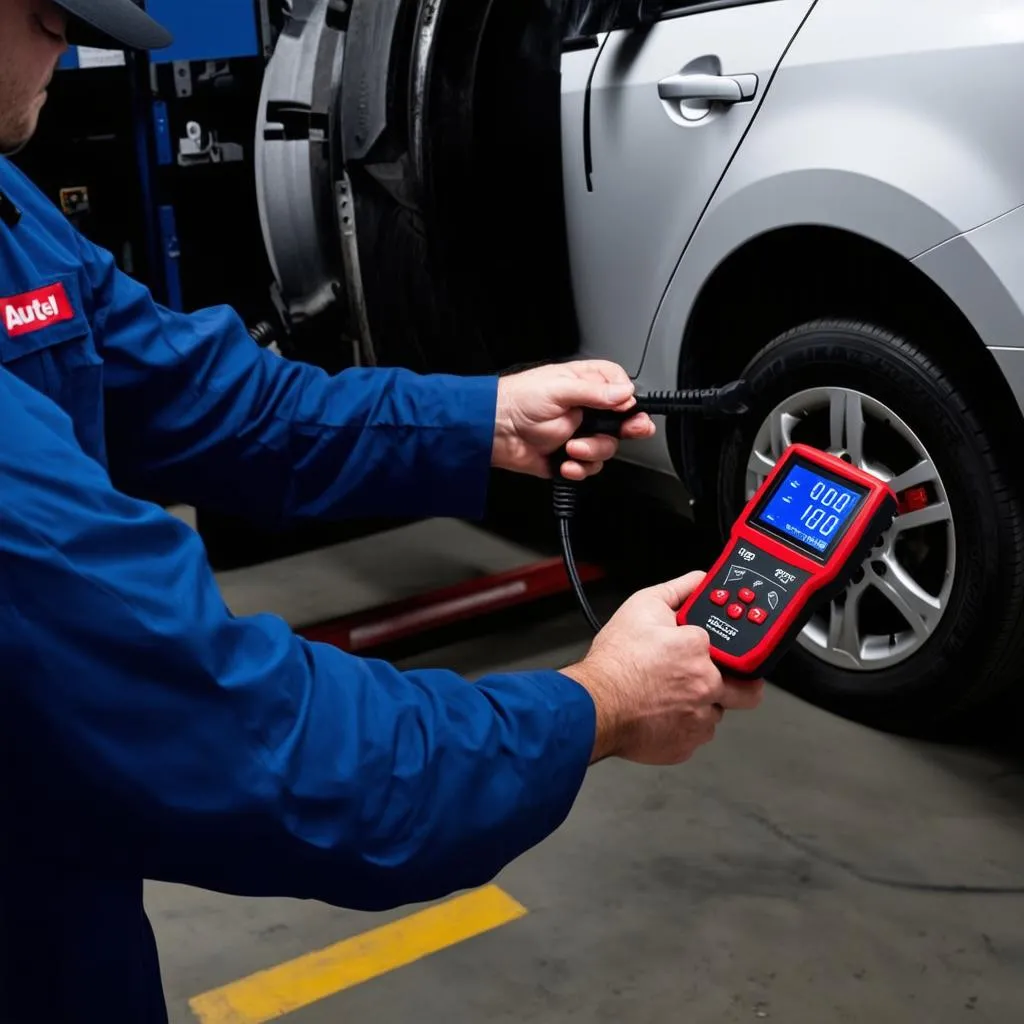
[0,371,595,909]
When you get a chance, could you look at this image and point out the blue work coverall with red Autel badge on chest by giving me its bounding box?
[0,160,595,1024]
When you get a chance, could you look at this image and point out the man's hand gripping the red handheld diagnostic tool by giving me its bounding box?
[562,572,764,765]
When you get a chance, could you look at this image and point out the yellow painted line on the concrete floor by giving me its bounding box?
[188,886,526,1024]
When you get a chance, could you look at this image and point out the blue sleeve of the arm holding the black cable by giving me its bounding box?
[79,238,498,525]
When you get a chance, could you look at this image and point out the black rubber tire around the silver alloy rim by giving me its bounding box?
[717,321,1024,736]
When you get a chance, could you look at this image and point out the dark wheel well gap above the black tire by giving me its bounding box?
[668,223,1024,512]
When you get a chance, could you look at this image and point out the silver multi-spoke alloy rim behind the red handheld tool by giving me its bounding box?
[745,387,956,672]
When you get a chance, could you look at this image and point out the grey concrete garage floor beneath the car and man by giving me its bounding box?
[147,522,1024,1024]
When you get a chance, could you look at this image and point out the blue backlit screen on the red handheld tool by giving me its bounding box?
[757,464,866,555]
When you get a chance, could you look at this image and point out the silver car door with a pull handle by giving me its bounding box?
[563,0,816,374]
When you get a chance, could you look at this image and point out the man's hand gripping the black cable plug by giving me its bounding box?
[492,359,654,480]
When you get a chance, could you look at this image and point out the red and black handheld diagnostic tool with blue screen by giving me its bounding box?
[676,444,897,679]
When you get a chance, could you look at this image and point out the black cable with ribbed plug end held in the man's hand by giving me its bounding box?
[551,381,748,633]
